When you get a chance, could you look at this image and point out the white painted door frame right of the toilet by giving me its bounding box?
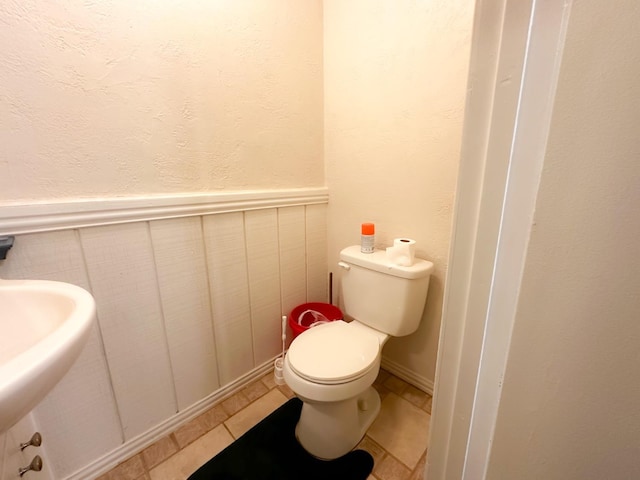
[425,0,571,480]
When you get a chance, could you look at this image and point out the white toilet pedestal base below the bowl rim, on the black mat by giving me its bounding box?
[296,387,380,460]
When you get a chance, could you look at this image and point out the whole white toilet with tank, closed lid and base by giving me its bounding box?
[284,245,433,459]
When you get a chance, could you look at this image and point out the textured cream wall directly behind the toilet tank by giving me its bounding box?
[324,0,473,383]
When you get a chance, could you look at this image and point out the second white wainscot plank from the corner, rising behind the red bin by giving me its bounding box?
[278,207,307,315]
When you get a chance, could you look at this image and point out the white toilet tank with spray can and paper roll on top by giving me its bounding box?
[339,245,433,337]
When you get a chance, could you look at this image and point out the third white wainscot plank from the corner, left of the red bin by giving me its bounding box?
[245,209,282,365]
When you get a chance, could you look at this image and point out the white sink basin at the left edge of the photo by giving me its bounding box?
[0,279,96,434]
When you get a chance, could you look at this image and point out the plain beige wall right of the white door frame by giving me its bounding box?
[486,0,640,480]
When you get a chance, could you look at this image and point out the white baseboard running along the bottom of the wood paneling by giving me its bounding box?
[65,357,276,480]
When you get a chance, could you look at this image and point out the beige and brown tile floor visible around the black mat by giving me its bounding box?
[98,370,431,480]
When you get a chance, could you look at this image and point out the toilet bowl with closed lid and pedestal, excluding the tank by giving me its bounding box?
[284,320,387,459]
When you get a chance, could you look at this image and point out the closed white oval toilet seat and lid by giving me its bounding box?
[287,321,380,385]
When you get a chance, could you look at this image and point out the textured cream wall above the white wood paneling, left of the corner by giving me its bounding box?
[0,0,324,202]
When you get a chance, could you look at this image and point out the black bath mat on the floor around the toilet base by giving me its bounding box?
[188,398,373,480]
